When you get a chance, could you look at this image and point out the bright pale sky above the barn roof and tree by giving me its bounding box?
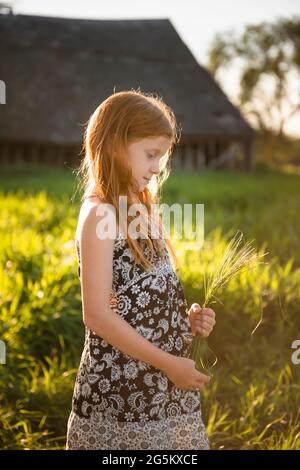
[7,0,300,136]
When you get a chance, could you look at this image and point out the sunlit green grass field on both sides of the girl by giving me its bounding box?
[0,166,300,449]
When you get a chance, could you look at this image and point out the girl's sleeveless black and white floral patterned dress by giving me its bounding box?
[66,234,209,450]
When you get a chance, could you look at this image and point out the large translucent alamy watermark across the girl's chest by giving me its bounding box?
[96,196,204,250]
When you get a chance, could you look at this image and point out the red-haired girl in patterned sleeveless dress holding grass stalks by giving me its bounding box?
[66,91,215,450]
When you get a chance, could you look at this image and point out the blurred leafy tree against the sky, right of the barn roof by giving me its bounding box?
[208,17,300,140]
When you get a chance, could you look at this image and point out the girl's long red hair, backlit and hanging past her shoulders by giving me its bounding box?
[79,90,179,270]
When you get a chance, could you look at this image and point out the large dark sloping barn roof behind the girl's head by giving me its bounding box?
[0,15,253,143]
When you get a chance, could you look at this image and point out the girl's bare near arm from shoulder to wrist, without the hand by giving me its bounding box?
[77,202,175,371]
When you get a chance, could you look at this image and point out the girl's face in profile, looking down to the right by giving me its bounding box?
[128,136,172,191]
